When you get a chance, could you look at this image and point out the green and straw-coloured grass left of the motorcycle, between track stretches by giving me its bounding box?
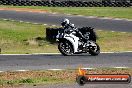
[0,20,57,53]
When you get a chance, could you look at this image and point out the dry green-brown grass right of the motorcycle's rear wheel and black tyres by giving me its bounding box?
[96,30,132,52]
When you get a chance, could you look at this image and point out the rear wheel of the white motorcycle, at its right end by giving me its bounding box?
[89,42,100,56]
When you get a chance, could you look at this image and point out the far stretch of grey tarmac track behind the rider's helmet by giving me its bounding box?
[0,10,132,32]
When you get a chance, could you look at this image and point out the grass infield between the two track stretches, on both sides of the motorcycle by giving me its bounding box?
[0,19,132,54]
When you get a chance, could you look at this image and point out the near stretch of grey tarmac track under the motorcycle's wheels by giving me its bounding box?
[0,53,132,71]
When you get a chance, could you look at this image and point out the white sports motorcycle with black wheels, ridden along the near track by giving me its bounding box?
[56,28,100,56]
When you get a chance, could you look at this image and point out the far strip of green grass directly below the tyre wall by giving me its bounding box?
[0,6,132,19]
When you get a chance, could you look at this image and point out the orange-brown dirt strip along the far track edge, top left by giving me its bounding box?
[0,8,48,13]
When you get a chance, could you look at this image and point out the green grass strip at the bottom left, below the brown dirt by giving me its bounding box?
[0,77,73,85]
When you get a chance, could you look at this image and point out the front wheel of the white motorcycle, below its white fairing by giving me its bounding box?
[58,41,74,56]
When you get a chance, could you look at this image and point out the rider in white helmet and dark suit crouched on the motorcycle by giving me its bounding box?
[61,18,87,42]
